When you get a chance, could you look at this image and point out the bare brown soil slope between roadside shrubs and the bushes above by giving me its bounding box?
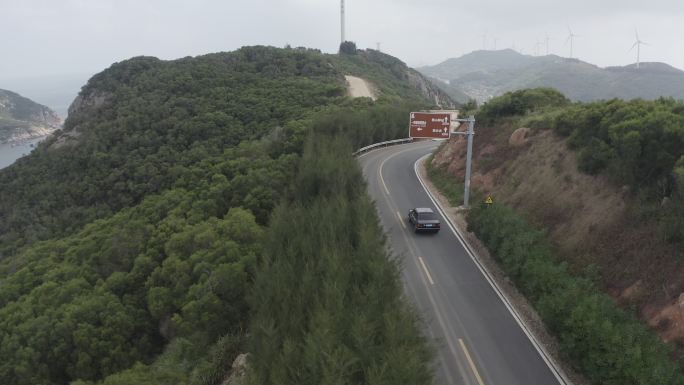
[433,127,684,352]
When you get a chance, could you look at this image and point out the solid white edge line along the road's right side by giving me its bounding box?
[413,154,571,385]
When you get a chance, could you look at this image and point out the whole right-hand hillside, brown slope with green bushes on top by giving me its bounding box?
[434,90,684,358]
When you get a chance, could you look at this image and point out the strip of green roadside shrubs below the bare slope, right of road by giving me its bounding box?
[468,203,684,385]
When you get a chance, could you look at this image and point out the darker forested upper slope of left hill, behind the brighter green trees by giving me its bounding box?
[0,47,345,254]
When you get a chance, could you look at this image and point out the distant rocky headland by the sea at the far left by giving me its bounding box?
[0,89,62,143]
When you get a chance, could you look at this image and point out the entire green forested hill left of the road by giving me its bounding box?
[0,47,444,385]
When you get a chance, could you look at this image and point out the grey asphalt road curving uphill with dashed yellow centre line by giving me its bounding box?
[359,142,561,385]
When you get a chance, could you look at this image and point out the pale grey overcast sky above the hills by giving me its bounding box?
[0,0,684,81]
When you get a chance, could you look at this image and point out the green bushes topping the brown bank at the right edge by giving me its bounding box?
[551,99,684,245]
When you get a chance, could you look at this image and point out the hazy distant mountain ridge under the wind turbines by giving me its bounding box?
[418,49,684,103]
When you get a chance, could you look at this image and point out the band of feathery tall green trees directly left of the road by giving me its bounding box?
[250,133,432,385]
